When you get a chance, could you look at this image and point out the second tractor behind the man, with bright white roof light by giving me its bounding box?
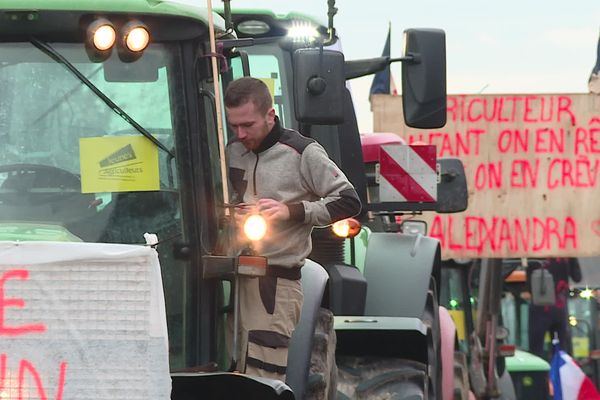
[218,2,466,398]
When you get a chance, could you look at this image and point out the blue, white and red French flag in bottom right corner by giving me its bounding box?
[550,340,600,400]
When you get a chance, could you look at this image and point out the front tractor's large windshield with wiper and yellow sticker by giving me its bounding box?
[0,42,189,366]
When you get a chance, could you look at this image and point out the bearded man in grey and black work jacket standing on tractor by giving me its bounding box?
[224,77,361,381]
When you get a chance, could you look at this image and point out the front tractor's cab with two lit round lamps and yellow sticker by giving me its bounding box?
[0,1,220,368]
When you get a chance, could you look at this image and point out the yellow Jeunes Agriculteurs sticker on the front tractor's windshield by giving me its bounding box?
[79,136,160,193]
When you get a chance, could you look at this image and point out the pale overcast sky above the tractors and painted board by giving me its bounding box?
[200,0,600,132]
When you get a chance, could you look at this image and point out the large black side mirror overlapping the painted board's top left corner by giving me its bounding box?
[402,29,446,128]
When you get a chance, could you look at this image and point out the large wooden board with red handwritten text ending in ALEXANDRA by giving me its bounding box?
[372,94,600,258]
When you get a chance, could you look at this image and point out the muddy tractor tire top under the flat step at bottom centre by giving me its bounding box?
[337,356,429,400]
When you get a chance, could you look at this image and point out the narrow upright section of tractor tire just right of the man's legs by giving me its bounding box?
[305,308,338,400]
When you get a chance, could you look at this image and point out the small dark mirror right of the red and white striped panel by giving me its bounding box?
[435,158,469,214]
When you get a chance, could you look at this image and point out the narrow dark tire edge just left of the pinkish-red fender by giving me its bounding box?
[422,290,442,400]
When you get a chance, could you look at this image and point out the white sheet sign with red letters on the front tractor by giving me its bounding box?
[0,242,171,400]
